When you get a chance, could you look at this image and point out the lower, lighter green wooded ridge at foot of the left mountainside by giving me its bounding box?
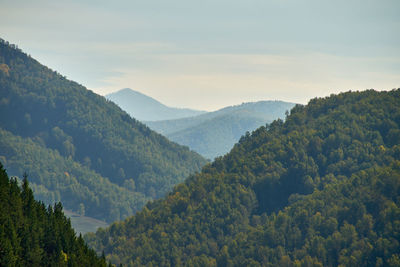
[0,129,149,222]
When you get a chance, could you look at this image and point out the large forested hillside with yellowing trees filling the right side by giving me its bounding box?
[85,89,400,266]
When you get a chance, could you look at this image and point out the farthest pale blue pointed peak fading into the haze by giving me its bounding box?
[105,88,205,121]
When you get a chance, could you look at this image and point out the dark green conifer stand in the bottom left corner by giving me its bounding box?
[0,163,111,267]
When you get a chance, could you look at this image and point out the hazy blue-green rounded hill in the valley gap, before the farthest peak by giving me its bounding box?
[146,101,294,159]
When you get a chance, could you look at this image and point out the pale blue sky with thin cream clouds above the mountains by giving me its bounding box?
[0,0,400,111]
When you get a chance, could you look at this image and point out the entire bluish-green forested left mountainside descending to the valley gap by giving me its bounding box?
[0,40,206,222]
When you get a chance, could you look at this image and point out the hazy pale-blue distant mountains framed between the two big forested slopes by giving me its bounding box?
[106,89,295,159]
